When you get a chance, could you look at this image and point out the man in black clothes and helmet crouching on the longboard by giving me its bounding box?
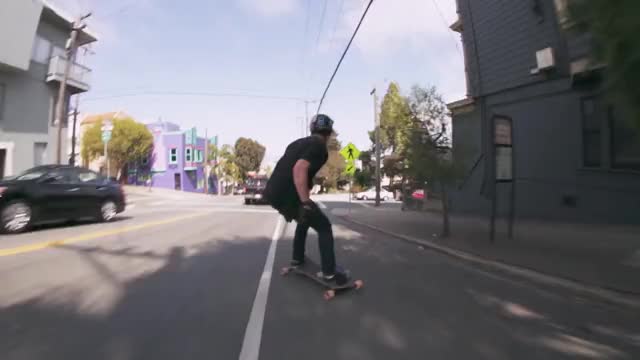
[264,114,349,285]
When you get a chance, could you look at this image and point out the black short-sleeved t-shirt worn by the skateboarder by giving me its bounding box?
[265,135,329,205]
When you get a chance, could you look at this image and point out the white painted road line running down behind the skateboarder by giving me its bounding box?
[239,216,286,360]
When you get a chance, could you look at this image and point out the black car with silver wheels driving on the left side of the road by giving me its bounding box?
[0,165,125,233]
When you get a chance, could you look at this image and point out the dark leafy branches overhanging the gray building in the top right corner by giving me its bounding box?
[569,0,640,127]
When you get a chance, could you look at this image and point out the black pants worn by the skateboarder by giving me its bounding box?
[293,209,336,275]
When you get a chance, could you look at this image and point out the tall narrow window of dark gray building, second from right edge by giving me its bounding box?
[582,97,603,167]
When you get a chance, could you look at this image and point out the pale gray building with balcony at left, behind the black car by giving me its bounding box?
[0,0,96,177]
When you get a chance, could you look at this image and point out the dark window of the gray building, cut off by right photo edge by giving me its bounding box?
[608,107,640,170]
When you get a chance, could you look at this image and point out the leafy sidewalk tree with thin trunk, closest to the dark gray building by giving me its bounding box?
[405,86,463,237]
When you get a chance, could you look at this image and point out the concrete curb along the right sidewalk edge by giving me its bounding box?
[339,215,640,309]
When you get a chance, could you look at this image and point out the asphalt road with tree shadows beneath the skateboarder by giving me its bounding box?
[0,194,640,360]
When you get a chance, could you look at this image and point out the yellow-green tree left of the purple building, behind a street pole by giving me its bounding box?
[82,118,153,180]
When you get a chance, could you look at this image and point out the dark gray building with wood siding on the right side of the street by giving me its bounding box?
[449,0,640,223]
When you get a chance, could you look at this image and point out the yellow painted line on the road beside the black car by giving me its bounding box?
[0,212,207,257]
